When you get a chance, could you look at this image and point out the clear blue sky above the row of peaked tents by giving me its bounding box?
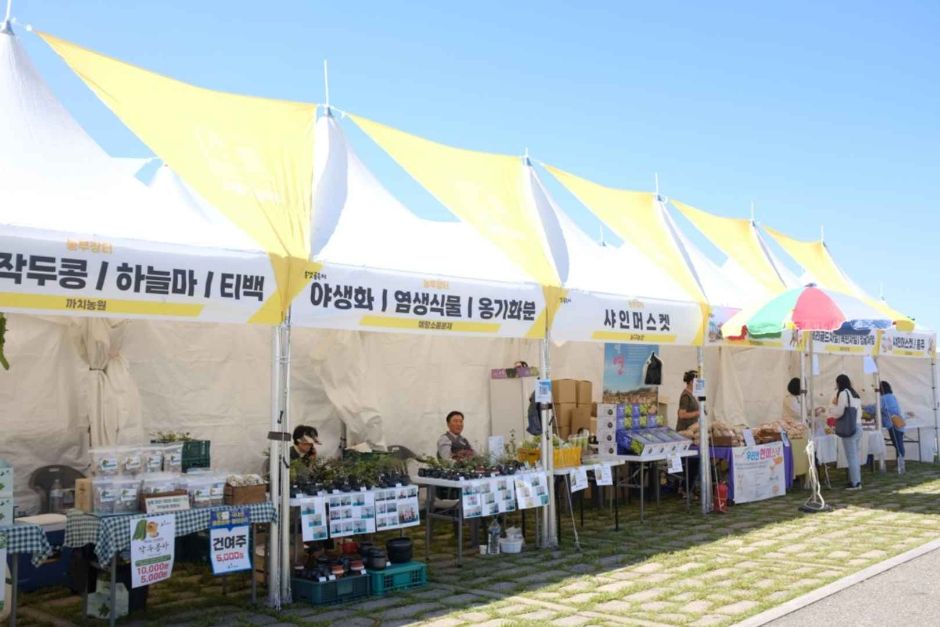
[13,0,940,329]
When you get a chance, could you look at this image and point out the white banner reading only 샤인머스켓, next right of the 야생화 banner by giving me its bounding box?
[552,290,704,346]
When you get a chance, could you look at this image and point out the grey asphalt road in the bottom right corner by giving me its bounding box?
[767,550,940,627]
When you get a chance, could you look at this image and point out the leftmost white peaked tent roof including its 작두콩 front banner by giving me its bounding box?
[0,31,273,321]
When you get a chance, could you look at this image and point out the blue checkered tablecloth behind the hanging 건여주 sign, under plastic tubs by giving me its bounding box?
[65,501,277,564]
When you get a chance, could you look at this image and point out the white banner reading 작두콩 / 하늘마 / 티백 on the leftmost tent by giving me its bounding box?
[0,228,276,322]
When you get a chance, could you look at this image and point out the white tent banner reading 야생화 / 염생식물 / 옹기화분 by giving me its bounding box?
[291,264,545,337]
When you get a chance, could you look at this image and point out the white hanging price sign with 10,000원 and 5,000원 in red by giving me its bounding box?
[130,514,176,588]
